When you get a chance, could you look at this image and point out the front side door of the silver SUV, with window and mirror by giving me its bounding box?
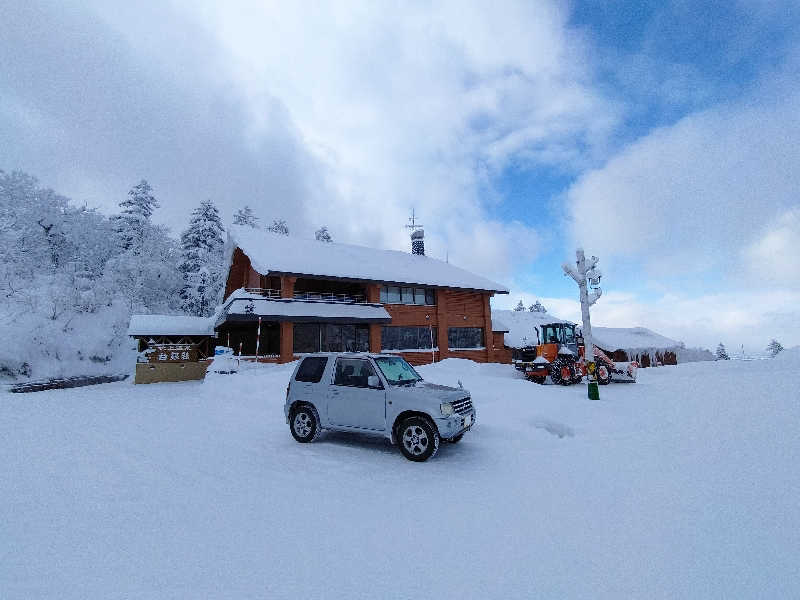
[328,358,386,431]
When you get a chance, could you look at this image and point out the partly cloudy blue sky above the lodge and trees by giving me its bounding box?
[0,0,800,352]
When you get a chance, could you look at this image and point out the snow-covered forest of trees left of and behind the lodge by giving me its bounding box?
[0,170,330,378]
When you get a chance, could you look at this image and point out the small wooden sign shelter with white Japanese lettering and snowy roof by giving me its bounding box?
[128,315,216,383]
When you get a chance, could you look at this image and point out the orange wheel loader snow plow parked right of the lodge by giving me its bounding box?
[514,323,639,385]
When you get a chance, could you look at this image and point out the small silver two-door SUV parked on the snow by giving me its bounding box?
[284,353,475,461]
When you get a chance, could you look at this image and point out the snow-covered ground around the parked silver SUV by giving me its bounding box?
[0,356,800,600]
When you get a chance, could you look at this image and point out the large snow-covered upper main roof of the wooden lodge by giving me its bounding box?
[228,225,508,294]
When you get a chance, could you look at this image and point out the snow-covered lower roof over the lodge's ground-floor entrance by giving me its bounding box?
[215,289,392,326]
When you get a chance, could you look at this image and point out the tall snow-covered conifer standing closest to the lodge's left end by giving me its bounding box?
[179,200,225,316]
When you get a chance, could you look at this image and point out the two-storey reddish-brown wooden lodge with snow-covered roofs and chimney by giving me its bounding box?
[213,226,510,364]
